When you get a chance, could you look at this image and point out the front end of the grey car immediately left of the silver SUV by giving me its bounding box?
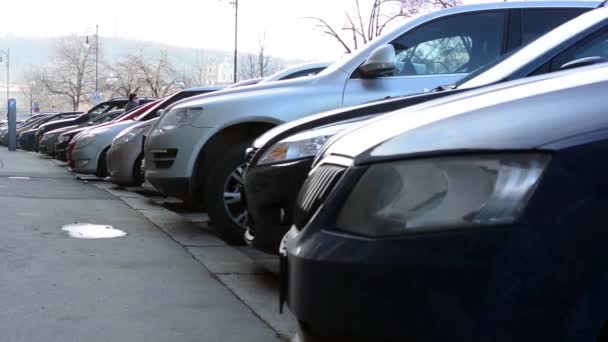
[106,118,158,186]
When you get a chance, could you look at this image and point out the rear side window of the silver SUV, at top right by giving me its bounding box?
[521,8,586,44]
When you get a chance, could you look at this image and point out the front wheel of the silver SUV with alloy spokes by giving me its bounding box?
[205,144,249,244]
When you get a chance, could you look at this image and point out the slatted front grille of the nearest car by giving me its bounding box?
[294,164,346,229]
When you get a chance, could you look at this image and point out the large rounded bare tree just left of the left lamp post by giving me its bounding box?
[40,35,96,110]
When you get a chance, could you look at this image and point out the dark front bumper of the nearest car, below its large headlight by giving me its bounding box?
[281,219,607,341]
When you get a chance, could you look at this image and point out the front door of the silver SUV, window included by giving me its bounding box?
[343,9,509,106]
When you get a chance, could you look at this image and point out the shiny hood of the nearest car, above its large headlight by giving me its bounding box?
[322,65,608,163]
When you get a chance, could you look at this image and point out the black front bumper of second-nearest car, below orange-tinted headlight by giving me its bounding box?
[245,158,313,254]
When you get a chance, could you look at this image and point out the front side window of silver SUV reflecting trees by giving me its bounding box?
[392,11,506,76]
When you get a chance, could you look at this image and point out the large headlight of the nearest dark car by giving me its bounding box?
[337,154,550,237]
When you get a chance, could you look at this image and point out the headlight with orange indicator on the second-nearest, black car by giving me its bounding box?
[258,122,354,165]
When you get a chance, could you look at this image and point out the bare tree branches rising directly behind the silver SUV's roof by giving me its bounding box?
[305,0,461,53]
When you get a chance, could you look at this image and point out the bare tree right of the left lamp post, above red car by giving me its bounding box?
[129,50,183,97]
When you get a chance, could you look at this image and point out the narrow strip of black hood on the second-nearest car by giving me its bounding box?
[253,89,460,149]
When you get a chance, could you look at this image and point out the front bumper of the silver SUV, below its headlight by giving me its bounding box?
[144,126,211,199]
